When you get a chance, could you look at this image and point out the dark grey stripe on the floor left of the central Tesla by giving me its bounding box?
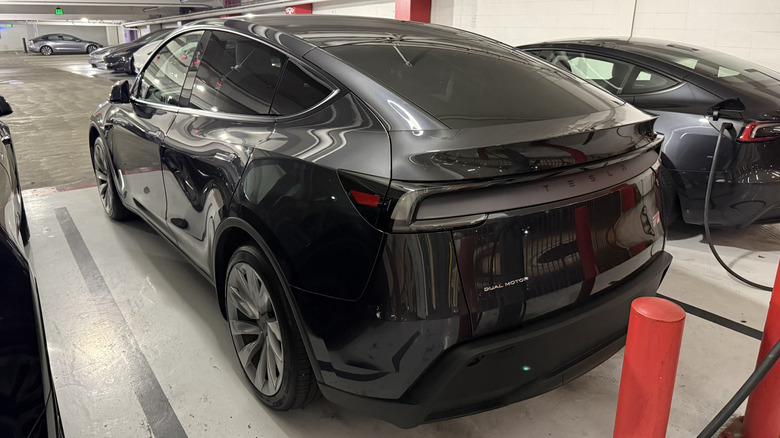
[54,207,187,438]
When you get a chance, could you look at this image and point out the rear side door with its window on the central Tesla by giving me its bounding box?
[162,31,286,272]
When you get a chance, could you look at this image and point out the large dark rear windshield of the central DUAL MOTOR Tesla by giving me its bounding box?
[326,44,622,129]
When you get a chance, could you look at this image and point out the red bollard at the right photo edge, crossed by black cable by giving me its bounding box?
[743,265,780,438]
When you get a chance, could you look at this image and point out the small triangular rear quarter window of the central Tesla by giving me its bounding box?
[273,62,331,115]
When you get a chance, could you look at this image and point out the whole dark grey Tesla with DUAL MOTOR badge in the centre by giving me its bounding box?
[89,16,671,427]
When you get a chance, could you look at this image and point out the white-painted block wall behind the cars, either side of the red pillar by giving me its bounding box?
[313,0,780,71]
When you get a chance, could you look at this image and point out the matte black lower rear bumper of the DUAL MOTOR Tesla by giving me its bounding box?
[320,251,672,428]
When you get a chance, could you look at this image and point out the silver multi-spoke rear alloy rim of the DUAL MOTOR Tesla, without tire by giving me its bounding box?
[226,262,284,396]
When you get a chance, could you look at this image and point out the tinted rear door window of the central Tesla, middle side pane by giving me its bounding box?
[190,32,285,115]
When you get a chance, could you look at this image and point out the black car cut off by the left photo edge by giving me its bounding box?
[0,96,62,438]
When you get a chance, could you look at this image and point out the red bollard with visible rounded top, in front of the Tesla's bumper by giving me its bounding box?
[613,297,685,438]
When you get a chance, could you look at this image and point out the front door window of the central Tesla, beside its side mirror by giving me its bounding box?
[137,32,203,105]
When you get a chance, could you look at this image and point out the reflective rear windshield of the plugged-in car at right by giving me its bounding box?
[632,46,780,86]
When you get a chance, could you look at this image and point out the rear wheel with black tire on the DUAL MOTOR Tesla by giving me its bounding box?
[225,245,319,411]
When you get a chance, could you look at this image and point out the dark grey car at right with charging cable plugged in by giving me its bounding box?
[520,38,780,228]
